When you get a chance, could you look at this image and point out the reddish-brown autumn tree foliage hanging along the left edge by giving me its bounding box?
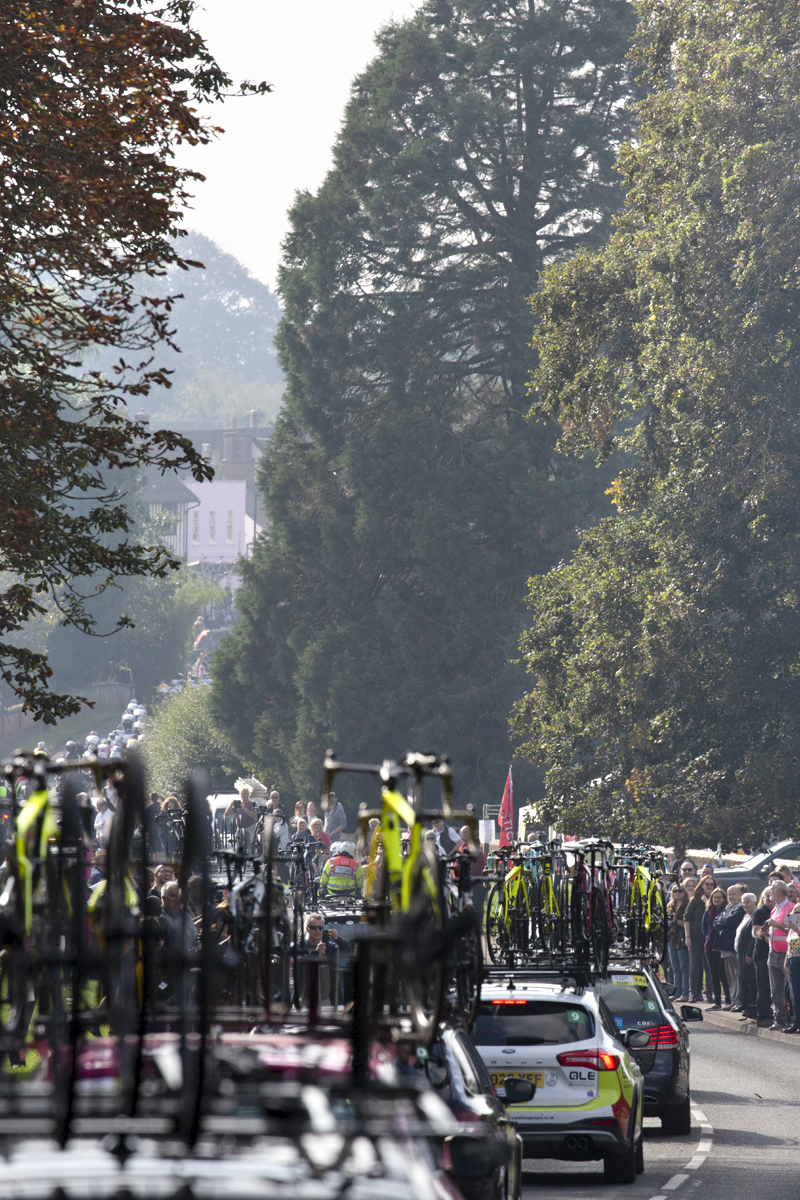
[0,0,266,720]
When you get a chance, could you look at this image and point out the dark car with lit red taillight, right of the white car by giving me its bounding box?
[595,964,703,1134]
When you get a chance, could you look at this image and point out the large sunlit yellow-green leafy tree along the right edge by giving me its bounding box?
[516,0,800,845]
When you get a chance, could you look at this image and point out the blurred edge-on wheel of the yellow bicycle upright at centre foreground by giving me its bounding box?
[407,842,445,1042]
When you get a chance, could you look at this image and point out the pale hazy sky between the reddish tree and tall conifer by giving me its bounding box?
[180,0,417,295]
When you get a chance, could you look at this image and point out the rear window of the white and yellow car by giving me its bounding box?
[474,1000,595,1046]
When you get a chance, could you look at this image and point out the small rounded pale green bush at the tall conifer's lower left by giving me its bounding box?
[145,686,243,796]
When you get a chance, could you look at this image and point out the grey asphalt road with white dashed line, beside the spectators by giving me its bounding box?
[523,1025,800,1200]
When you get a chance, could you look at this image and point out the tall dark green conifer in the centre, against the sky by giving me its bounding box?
[213,0,632,803]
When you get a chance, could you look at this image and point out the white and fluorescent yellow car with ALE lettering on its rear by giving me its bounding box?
[473,974,650,1183]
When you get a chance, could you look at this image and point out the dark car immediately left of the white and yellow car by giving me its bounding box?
[415,1028,525,1200]
